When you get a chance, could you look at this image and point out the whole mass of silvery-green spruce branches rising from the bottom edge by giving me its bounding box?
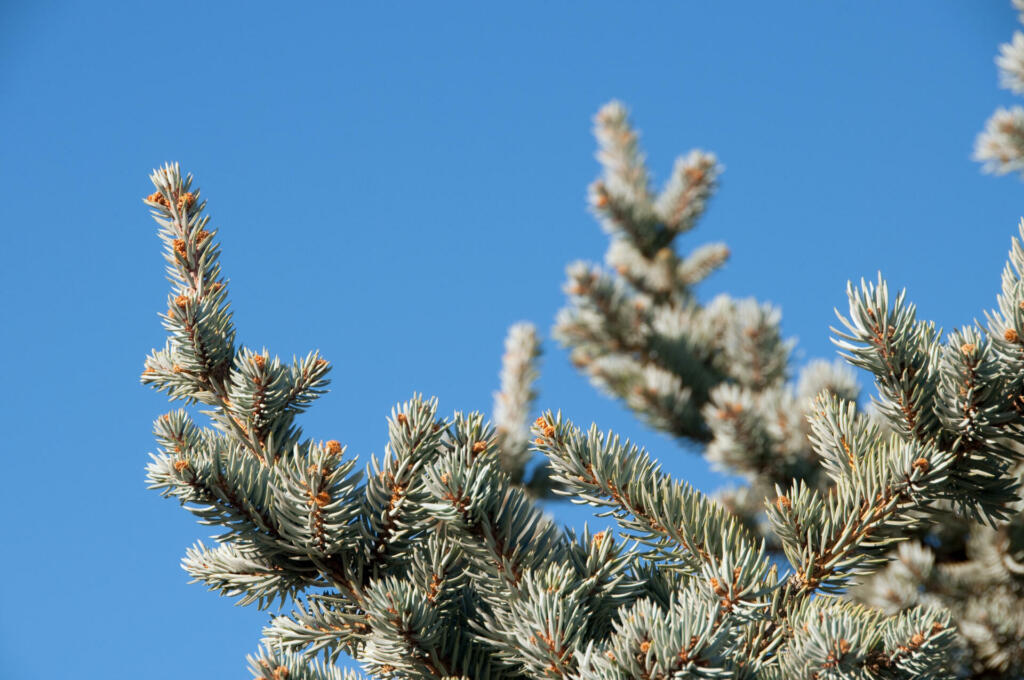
[142,11,1024,680]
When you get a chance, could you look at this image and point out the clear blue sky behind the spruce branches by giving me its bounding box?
[0,0,1024,679]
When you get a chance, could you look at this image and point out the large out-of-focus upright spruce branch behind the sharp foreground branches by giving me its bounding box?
[555,102,859,548]
